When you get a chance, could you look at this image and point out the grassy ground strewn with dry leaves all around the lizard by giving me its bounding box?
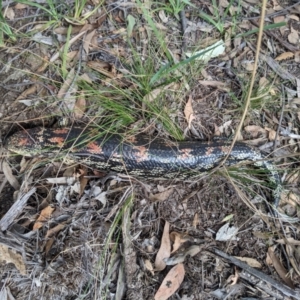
[0,0,300,299]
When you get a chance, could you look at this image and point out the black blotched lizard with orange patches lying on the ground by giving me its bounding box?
[7,127,282,206]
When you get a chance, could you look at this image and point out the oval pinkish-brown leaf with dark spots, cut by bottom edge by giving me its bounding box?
[154,264,185,300]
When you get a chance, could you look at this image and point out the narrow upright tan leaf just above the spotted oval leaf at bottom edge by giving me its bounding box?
[154,221,171,271]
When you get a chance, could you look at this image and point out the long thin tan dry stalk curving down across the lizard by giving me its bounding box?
[220,0,267,166]
